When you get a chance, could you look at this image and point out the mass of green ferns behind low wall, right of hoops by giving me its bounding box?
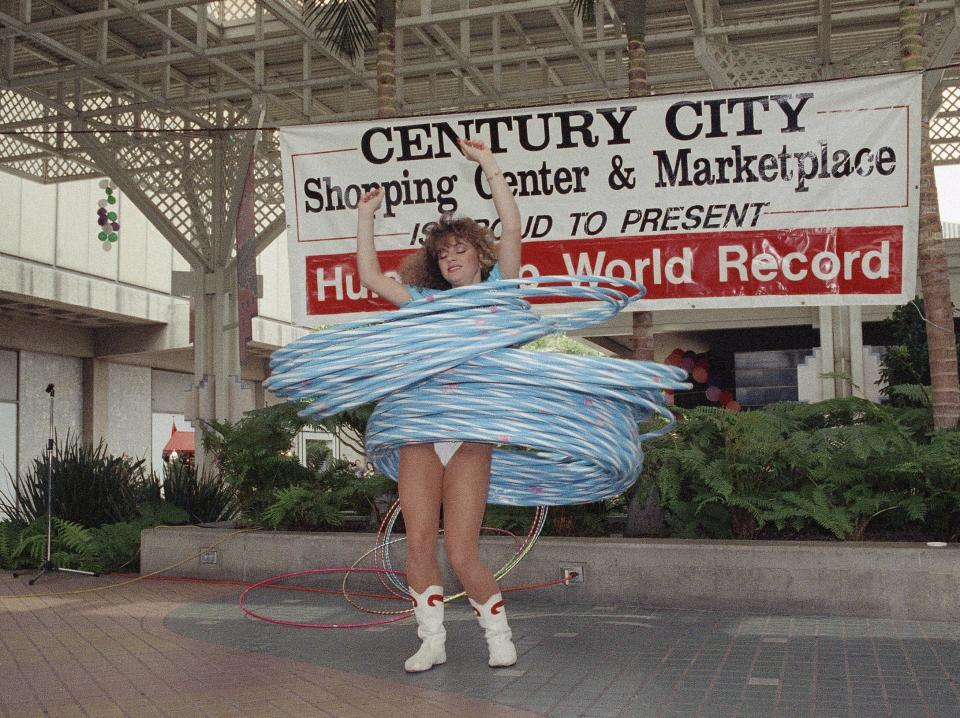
[648,399,948,539]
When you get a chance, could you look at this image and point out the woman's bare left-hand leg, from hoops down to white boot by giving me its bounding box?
[397,444,443,593]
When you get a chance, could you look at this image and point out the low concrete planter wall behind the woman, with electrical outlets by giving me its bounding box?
[141,527,960,621]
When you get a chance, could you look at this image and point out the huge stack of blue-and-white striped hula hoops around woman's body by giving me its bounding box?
[265,276,690,506]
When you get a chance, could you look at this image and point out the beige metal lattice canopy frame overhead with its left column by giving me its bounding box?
[0,0,960,428]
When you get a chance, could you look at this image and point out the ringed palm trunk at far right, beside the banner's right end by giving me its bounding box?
[900,0,960,429]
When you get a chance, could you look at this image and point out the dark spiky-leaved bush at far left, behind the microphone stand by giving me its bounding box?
[0,434,150,527]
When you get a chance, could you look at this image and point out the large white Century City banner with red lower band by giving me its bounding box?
[280,73,922,326]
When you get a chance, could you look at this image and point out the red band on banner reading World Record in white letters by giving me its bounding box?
[306,226,903,316]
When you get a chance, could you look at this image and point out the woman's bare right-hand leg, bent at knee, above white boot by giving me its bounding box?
[443,443,500,603]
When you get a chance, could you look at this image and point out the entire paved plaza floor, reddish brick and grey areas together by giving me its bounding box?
[0,575,960,718]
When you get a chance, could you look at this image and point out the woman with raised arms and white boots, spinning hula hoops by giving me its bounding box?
[357,139,520,673]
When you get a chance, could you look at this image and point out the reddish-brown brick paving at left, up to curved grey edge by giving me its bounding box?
[0,574,536,718]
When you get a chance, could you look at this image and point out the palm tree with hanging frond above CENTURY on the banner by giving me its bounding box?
[303,0,397,118]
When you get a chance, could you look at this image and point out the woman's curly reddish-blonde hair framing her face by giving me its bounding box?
[398,214,497,289]
